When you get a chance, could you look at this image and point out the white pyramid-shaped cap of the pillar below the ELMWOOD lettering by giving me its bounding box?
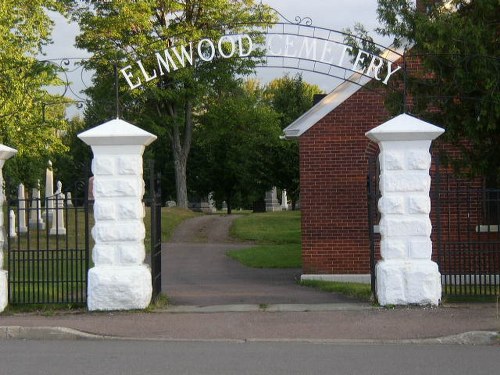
[78,119,157,146]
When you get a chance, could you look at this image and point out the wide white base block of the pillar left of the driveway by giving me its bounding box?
[87,265,152,311]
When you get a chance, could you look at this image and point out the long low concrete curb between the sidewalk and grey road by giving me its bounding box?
[0,326,500,345]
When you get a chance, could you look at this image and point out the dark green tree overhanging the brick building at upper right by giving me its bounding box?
[378,0,500,183]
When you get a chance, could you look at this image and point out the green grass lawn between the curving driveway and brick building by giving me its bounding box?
[228,211,302,268]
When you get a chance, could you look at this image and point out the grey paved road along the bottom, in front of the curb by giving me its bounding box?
[0,340,500,375]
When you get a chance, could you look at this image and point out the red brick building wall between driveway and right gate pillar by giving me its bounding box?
[300,89,388,274]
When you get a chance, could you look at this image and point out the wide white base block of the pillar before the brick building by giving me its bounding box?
[375,260,441,306]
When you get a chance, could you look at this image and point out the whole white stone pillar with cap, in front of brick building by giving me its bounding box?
[366,114,444,306]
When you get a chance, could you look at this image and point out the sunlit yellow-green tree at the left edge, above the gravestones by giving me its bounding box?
[0,0,72,184]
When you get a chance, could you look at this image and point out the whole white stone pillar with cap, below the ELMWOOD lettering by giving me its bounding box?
[78,119,156,311]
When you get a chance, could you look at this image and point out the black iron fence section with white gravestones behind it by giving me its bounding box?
[6,168,92,305]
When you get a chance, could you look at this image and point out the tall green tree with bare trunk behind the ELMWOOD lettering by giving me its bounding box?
[75,0,276,207]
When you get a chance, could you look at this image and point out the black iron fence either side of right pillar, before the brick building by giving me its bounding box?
[367,157,500,296]
